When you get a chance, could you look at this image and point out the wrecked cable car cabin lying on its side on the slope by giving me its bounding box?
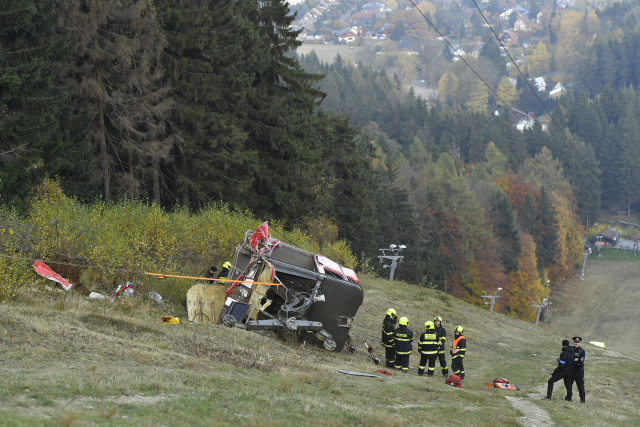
[222,222,364,351]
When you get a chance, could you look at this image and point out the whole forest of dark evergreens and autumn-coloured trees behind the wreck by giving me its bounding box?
[0,0,640,318]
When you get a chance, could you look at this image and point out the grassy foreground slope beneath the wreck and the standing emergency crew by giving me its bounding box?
[0,277,640,426]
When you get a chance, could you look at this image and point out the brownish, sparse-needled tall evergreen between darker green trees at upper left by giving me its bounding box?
[64,0,177,204]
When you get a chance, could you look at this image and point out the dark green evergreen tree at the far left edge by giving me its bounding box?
[0,0,74,209]
